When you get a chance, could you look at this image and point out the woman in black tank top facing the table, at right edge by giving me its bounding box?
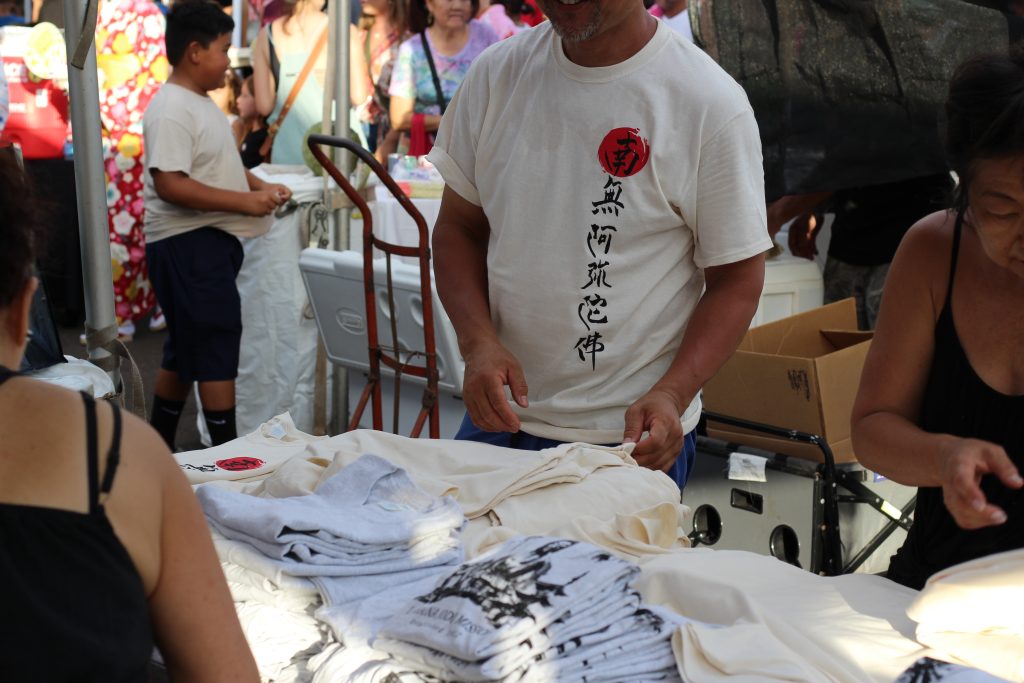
[853,53,1024,589]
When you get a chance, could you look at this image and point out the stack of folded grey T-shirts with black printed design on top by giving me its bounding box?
[374,537,684,683]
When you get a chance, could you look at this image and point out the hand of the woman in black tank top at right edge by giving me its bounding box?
[939,438,1024,529]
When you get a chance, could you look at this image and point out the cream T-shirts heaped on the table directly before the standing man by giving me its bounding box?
[245,429,689,557]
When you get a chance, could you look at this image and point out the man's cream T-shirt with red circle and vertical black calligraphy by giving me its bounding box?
[430,23,772,443]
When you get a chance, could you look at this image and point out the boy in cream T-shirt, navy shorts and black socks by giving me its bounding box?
[142,0,291,450]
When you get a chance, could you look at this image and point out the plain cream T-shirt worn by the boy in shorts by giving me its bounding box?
[142,83,271,244]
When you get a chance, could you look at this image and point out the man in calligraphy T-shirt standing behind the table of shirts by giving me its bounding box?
[430,0,771,484]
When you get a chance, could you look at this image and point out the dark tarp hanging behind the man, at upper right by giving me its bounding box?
[690,0,1008,200]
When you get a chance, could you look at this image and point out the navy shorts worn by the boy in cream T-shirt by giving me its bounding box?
[145,227,244,384]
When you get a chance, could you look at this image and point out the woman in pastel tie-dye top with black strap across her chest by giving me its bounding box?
[390,0,498,154]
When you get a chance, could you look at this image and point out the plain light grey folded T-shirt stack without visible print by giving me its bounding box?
[197,455,465,606]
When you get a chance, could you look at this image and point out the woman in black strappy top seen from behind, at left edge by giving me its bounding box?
[0,139,259,683]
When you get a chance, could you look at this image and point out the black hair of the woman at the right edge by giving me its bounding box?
[945,48,1024,212]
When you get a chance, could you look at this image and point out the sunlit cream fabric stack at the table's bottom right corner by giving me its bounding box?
[907,549,1024,683]
